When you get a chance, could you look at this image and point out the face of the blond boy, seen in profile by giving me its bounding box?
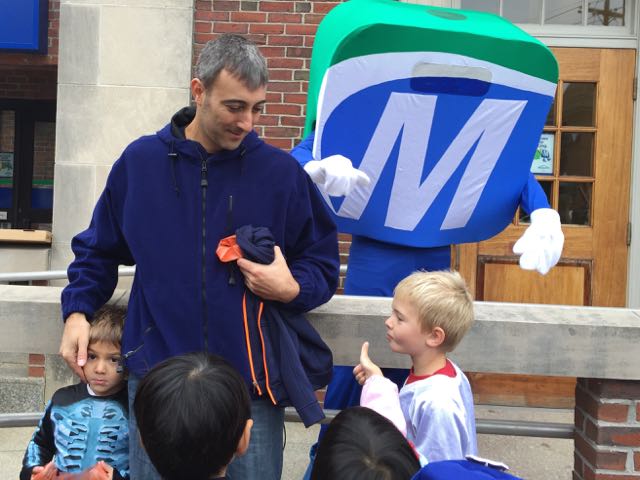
[384,297,427,356]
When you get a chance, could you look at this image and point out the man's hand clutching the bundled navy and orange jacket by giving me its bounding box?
[238,245,300,302]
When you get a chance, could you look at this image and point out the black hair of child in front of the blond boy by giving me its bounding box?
[311,407,420,480]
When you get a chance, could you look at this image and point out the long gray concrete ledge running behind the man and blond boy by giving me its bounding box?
[0,285,640,380]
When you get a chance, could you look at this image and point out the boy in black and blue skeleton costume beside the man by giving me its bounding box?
[20,307,129,480]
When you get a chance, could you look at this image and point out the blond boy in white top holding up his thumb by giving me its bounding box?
[354,271,477,462]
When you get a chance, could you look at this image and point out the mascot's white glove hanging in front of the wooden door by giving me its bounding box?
[513,208,564,275]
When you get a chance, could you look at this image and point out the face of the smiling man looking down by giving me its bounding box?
[191,70,267,153]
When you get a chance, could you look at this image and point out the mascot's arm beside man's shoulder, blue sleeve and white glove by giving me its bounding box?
[291,132,370,197]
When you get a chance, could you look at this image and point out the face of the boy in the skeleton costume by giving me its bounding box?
[82,342,124,397]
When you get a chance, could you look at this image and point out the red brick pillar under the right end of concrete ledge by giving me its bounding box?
[573,378,640,480]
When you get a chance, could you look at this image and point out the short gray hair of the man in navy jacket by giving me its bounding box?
[196,34,269,90]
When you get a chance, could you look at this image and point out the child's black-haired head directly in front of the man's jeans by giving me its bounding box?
[134,353,251,480]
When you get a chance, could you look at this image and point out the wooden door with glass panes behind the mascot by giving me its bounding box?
[454,48,636,407]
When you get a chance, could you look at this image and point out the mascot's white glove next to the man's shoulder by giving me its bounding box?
[304,155,371,197]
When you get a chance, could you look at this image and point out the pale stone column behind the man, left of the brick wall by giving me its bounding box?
[51,0,194,280]
